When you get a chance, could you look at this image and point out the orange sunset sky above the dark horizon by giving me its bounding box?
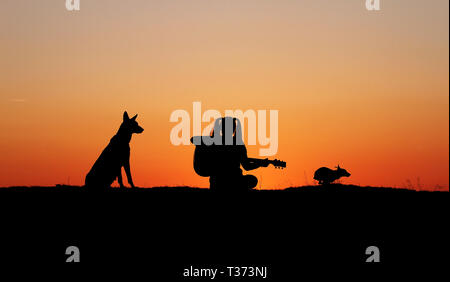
[0,0,449,190]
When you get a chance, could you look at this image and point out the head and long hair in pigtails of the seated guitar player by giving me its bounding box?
[211,117,244,145]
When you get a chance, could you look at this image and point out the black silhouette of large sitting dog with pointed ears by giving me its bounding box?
[85,112,144,189]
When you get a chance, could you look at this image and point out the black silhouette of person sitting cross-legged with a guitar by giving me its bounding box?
[191,117,269,191]
